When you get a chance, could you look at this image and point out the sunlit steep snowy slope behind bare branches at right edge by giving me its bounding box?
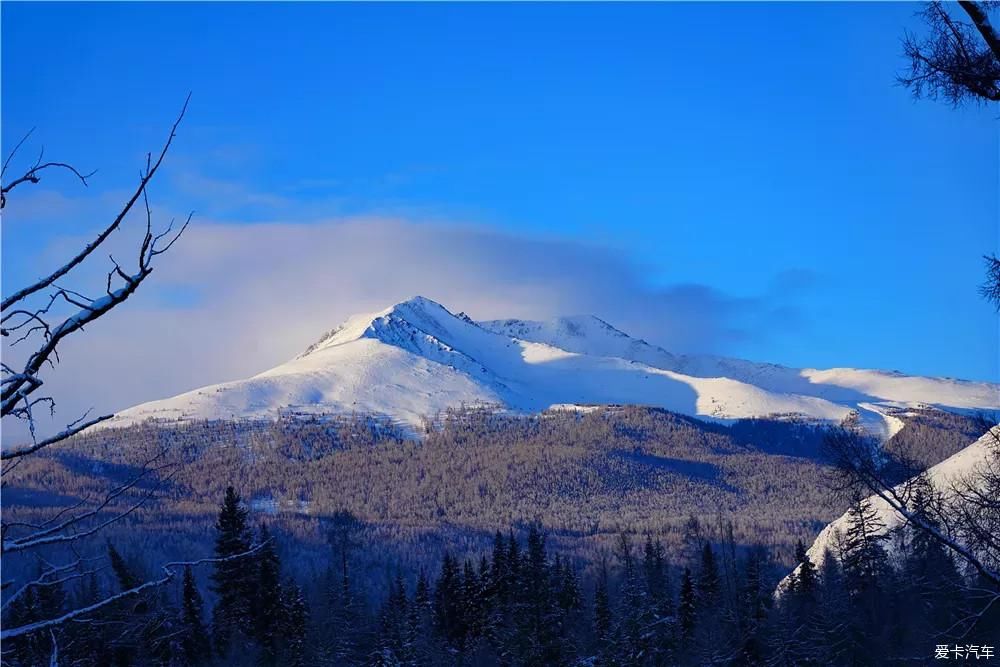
[778,426,1000,594]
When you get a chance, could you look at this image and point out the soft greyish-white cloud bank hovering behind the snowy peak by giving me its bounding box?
[5,214,812,439]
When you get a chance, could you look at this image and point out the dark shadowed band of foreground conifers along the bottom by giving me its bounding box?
[3,482,997,667]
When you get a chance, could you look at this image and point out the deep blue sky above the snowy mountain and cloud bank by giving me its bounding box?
[0,2,1000,398]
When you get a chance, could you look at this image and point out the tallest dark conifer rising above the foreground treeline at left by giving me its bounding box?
[212,486,254,655]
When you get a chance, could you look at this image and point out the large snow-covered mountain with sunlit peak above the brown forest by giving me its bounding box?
[103,297,1000,432]
